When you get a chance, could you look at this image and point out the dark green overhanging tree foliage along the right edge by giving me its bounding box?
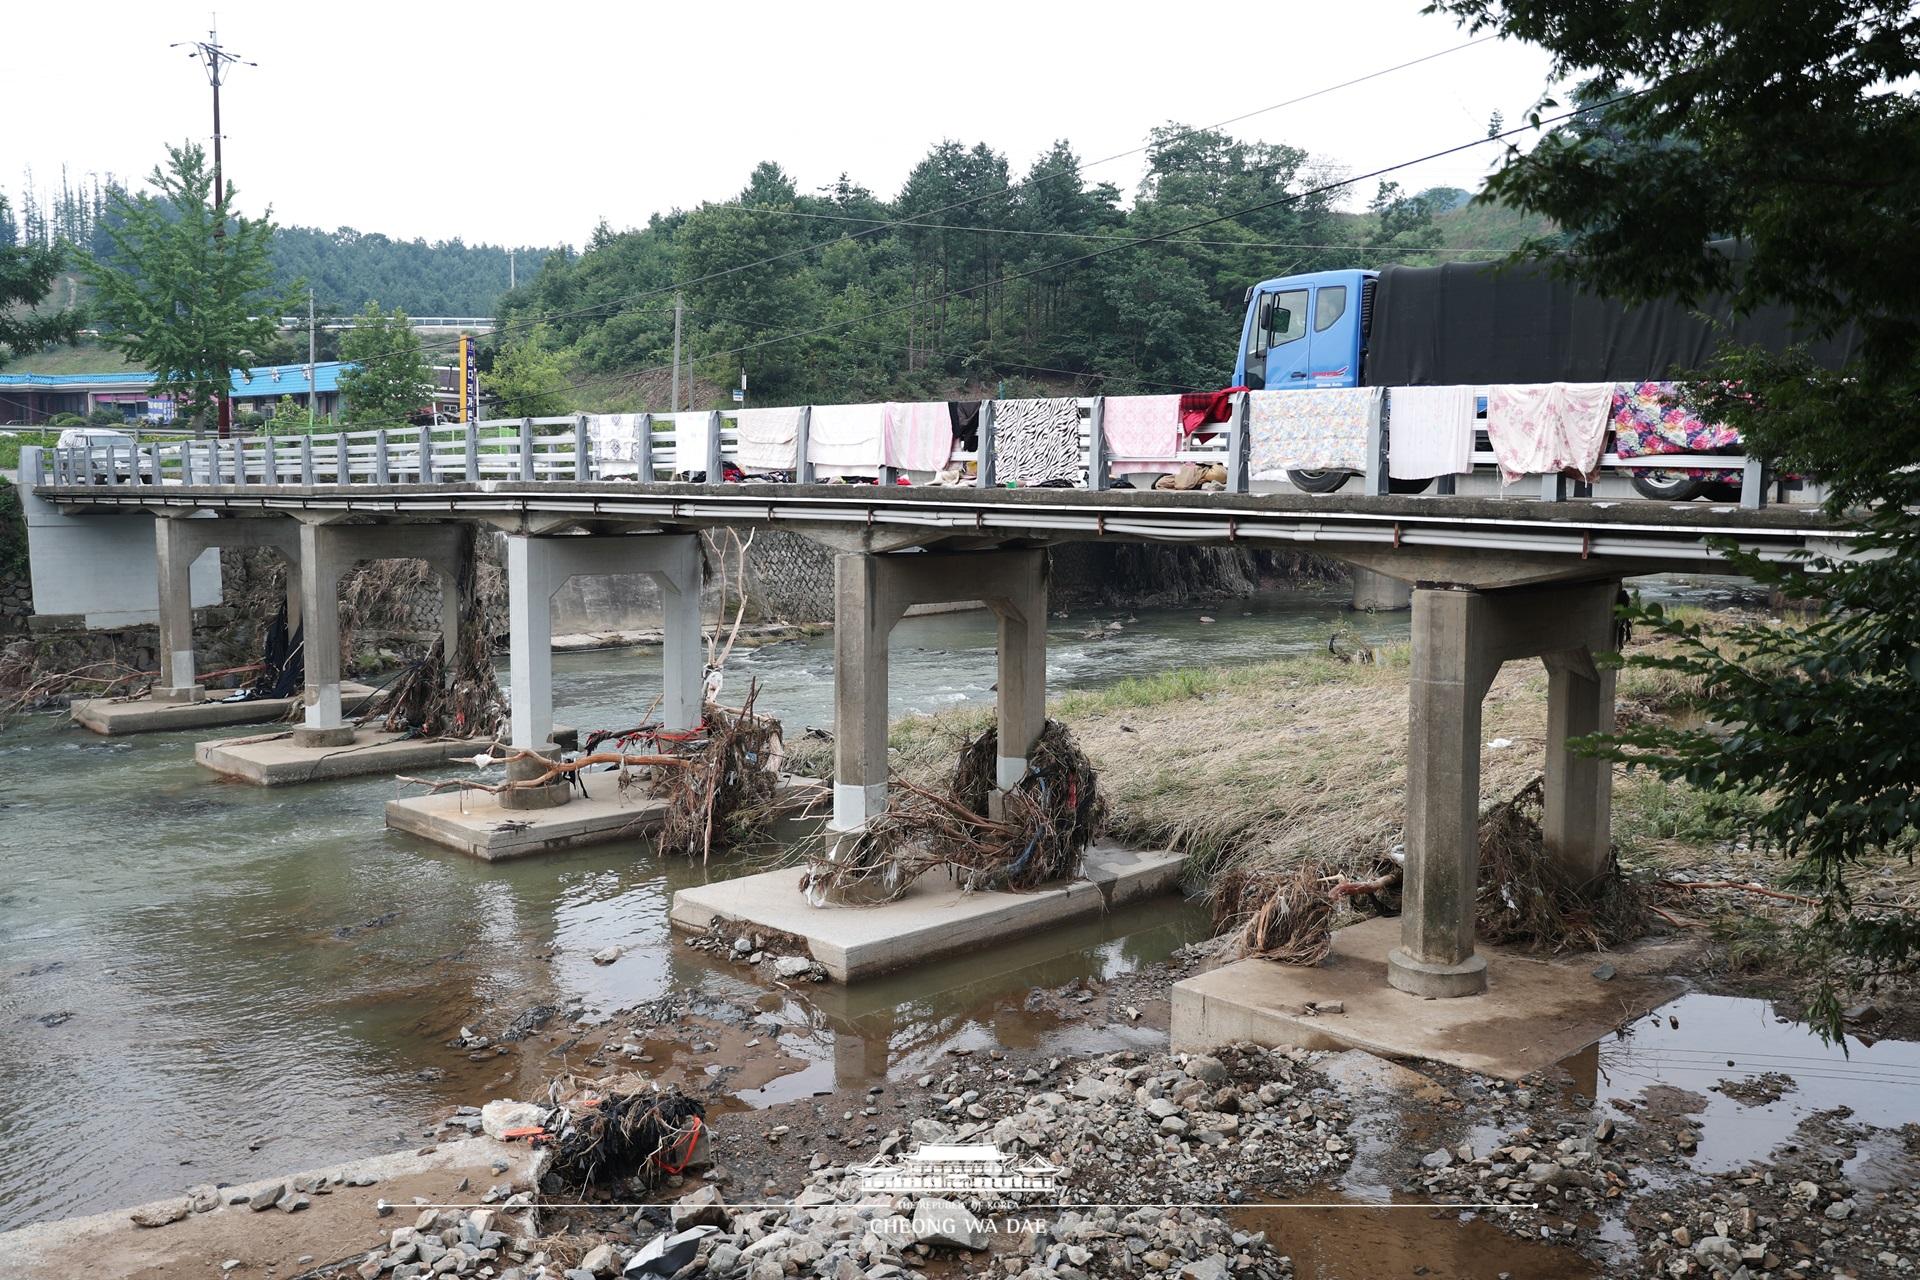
[1432,0,1920,1034]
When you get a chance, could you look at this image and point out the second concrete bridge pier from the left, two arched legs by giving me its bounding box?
[294,520,463,747]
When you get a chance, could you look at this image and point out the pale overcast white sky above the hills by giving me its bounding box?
[0,0,1548,244]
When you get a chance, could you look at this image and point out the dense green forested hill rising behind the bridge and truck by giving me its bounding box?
[499,127,1543,409]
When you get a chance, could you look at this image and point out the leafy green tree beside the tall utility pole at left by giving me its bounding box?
[88,142,290,427]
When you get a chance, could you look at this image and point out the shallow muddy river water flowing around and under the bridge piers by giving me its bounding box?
[0,593,1407,1230]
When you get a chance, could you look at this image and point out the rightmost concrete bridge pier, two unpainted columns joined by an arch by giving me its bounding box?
[1386,580,1620,996]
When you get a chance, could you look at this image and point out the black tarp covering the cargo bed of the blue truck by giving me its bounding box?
[1365,253,1857,386]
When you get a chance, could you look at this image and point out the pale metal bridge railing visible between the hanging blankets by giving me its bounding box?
[42,388,1766,507]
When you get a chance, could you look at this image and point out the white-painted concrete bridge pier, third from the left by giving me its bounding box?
[503,533,707,808]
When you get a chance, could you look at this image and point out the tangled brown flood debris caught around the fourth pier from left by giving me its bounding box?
[804,720,1106,902]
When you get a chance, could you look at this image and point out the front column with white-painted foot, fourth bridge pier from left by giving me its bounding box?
[831,553,894,831]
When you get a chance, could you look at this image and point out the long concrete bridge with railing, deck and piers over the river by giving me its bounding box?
[11,399,1849,996]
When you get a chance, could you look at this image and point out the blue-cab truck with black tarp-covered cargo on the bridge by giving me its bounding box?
[1229,255,1857,501]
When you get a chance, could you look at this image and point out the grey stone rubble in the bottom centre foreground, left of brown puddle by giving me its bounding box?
[337,1046,1320,1280]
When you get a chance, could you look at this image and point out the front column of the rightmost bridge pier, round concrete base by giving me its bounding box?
[1386,587,1500,996]
